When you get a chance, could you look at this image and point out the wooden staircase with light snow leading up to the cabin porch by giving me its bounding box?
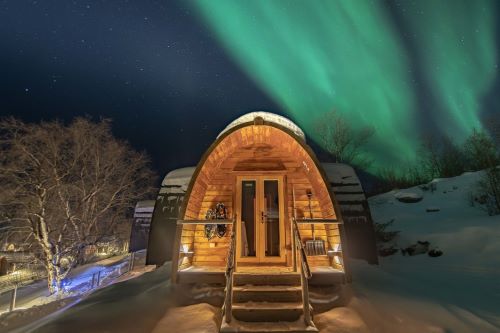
[220,273,318,333]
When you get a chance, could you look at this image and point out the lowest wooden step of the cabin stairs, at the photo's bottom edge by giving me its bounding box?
[220,317,319,333]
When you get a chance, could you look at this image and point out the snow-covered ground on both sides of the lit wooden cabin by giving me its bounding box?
[8,173,500,333]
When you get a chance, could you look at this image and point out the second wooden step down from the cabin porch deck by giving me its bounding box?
[233,285,302,303]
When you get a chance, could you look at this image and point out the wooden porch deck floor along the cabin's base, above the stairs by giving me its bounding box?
[177,266,345,286]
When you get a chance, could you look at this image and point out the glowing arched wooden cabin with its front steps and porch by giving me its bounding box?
[162,112,350,332]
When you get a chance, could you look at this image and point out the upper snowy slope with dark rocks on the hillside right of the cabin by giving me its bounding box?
[368,172,500,266]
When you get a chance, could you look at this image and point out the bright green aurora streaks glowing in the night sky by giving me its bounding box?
[192,0,498,168]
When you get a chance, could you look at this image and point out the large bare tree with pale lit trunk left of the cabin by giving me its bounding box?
[0,118,155,293]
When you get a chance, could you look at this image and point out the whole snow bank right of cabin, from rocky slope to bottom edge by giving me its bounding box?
[358,172,500,333]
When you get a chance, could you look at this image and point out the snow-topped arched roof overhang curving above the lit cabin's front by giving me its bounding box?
[181,112,338,219]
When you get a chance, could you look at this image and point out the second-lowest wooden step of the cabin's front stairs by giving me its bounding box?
[232,302,303,322]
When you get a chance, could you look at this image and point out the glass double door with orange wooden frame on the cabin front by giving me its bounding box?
[237,176,285,263]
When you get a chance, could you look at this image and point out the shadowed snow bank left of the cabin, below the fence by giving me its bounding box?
[31,263,175,333]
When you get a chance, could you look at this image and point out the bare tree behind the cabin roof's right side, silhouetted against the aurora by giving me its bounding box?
[315,111,375,169]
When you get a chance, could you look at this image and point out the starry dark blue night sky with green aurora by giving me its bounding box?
[0,0,500,174]
